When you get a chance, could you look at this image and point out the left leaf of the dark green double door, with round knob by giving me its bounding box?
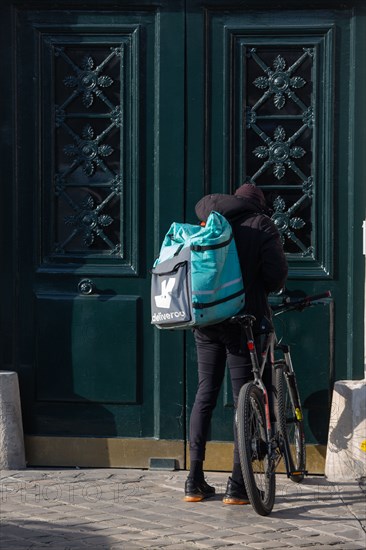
[1,0,184,466]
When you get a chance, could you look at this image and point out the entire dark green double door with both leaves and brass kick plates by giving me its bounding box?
[1,0,366,470]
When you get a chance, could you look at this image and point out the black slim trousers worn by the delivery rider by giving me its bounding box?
[189,322,252,463]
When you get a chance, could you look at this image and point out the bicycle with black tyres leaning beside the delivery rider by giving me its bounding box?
[231,291,331,516]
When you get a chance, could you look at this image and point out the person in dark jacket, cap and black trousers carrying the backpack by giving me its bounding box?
[184,184,288,504]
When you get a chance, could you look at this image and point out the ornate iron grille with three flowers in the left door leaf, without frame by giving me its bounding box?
[54,46,123,256]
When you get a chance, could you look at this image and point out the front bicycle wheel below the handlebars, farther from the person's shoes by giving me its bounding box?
[275,362,306,483]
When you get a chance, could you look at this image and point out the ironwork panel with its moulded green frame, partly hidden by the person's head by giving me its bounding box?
[228,29,333,277]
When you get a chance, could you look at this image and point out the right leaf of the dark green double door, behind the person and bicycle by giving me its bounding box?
[186,0,366,471]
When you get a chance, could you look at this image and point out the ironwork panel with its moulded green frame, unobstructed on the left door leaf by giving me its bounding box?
[40,27,142,267]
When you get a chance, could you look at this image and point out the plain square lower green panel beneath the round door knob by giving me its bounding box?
[36,294,139,405]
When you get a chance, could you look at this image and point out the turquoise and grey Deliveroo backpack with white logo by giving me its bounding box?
[151,212,244,329]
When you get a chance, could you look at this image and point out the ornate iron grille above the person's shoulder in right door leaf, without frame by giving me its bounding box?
[244,46,315,257]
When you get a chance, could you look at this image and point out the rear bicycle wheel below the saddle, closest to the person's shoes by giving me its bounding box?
[236,382,276,516]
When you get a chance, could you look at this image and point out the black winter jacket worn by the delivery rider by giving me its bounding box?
[196,193,288,322]
